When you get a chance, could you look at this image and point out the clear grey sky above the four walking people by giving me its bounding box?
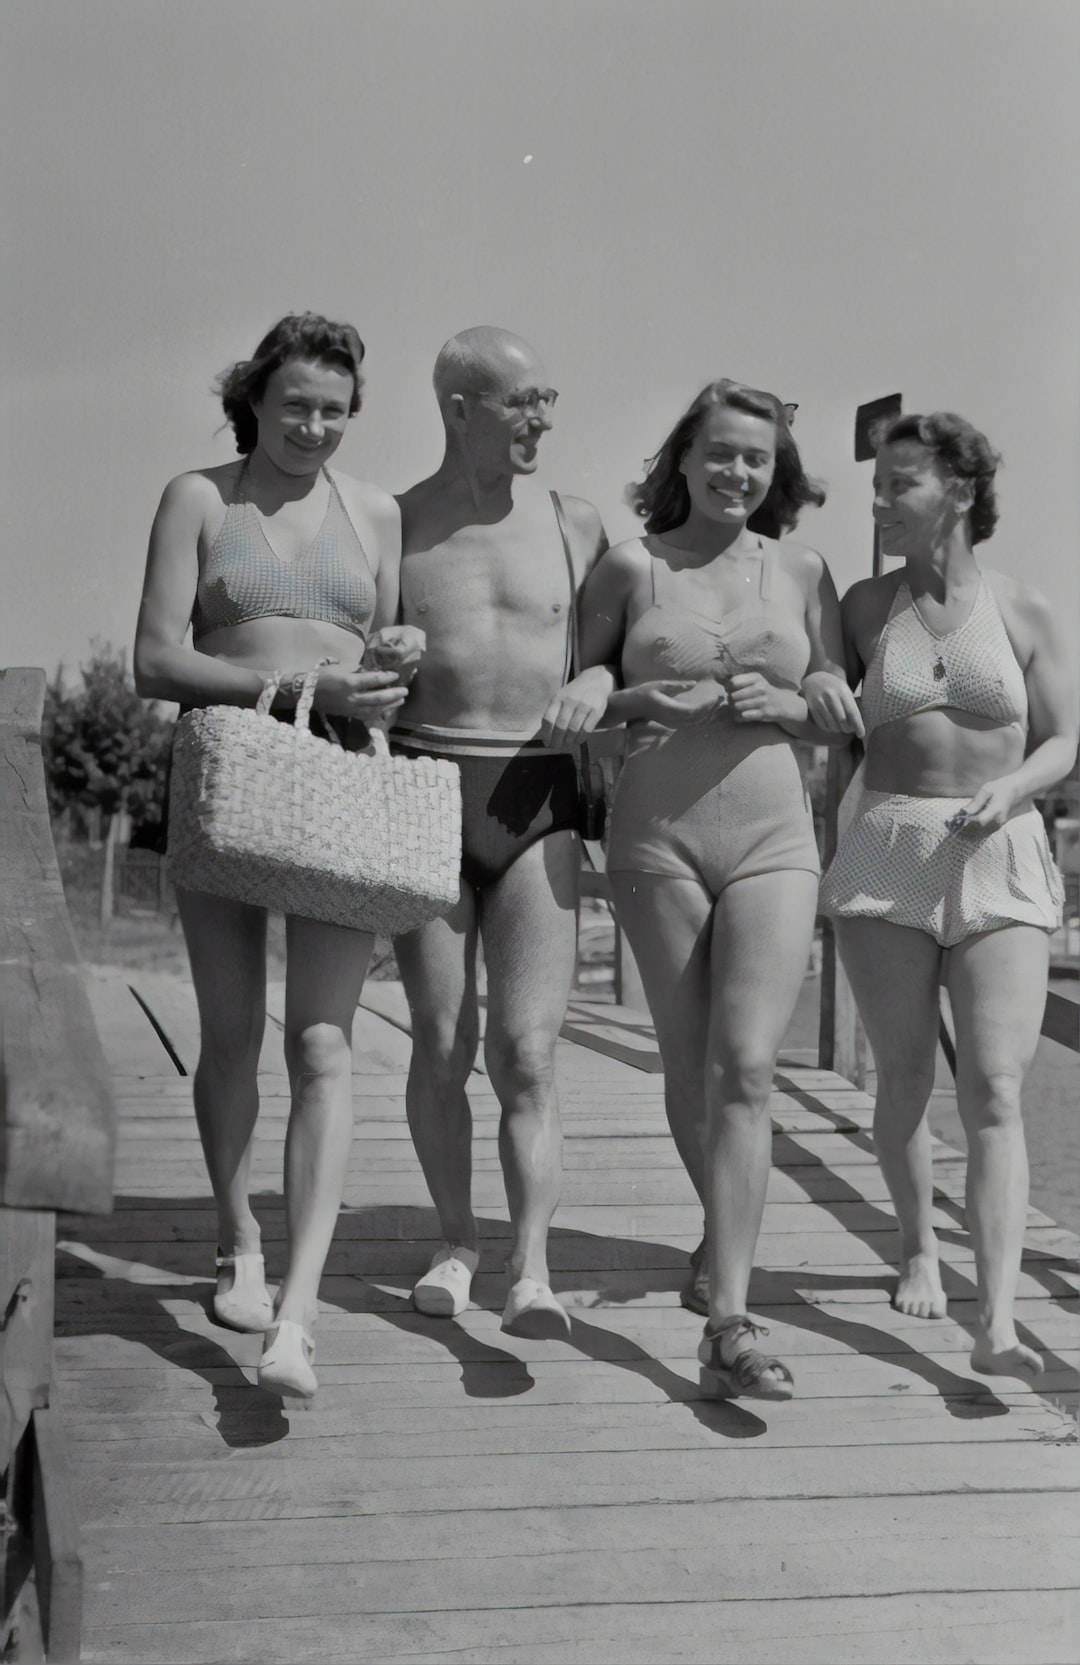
[0,0,1080,671]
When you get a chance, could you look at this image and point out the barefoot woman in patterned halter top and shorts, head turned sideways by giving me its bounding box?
[805,411,1077,1379]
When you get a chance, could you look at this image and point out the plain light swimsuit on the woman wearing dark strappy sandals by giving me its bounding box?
[607,538,820,896]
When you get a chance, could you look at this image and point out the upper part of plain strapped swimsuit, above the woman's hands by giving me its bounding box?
[622,538,810,702]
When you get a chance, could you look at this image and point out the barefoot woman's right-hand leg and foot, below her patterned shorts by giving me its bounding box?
[947,926,1050,1380]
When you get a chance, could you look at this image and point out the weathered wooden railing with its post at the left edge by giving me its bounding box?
[0,669,115,1662]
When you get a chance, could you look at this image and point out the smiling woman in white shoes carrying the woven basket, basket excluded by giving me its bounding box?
[135,313,406,1397]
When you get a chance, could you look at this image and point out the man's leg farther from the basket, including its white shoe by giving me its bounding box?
[481,831,581,1335]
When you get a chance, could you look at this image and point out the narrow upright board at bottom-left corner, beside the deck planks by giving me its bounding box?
[33,1409,83,1665]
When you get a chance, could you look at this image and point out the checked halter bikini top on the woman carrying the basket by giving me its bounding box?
[191,468,374,641]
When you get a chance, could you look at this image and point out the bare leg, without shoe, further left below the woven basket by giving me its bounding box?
[176,889,266,1255]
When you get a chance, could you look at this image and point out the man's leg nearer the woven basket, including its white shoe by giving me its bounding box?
[394,884,479,1317]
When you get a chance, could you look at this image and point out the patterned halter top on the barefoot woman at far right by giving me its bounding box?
[862,578,1027,733]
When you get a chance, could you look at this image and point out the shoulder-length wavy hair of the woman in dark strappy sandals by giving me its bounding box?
[627,378,825,538]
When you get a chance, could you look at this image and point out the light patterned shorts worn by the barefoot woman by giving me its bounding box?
[820,789,1063,947]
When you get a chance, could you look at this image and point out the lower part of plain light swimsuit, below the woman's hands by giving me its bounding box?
[607,724,820,896]
